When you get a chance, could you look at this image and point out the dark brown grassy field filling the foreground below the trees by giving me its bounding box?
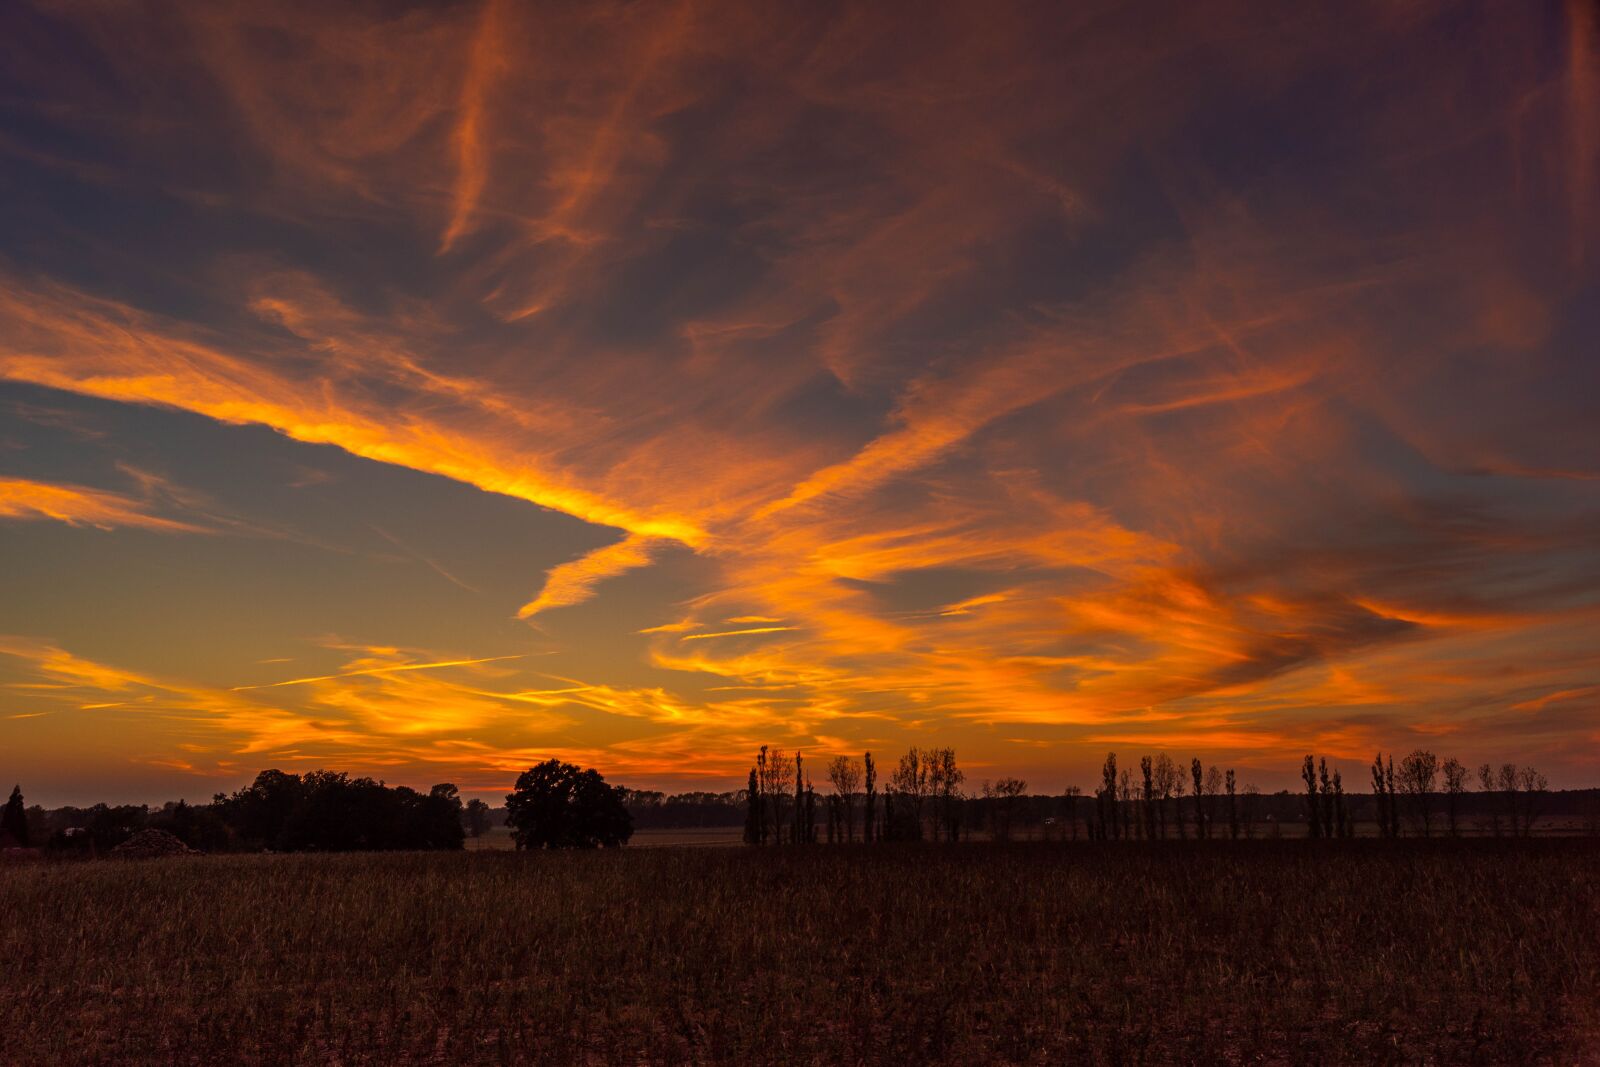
[0,840,1600,1065]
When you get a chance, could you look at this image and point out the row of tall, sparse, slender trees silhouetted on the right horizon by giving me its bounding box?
[739,745,1574,845]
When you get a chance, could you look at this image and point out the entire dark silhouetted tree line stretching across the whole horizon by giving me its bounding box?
[0,745,1574,853]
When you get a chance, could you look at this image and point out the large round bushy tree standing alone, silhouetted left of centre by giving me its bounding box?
[506,760,634,848]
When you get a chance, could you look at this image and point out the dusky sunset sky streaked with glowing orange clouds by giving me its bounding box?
[0,0,1600,803]
